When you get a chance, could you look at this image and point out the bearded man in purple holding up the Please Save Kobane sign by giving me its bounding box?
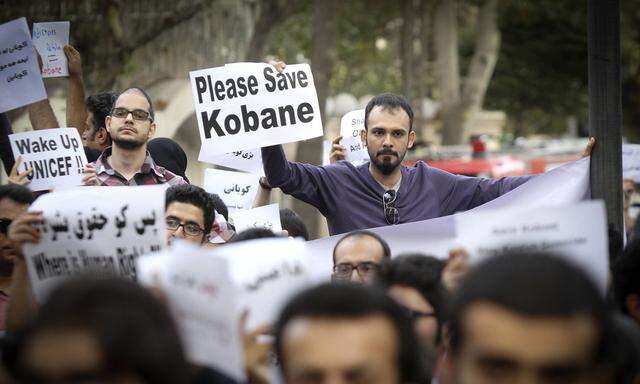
[261,93,552,235]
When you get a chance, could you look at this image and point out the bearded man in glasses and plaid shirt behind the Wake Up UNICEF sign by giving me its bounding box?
[84,88,186,186]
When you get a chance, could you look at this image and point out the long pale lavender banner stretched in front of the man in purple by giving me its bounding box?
[306,158,589,282]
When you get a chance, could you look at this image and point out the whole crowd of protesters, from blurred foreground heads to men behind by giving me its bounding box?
[0,42,640,384]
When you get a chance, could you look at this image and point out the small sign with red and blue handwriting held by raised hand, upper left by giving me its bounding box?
[33,21,69,77]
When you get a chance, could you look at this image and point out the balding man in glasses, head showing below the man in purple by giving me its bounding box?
[331,231,391,284]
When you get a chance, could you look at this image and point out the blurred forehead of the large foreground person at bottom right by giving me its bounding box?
[460,302,598,365]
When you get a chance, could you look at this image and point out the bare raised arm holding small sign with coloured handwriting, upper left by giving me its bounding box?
[64,45,87,137]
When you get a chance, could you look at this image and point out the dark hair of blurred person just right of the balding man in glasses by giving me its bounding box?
[377,254,447,342]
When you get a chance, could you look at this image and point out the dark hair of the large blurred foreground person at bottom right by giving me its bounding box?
[448,253,610,359]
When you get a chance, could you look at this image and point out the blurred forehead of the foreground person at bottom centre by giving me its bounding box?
[283,314,398,368]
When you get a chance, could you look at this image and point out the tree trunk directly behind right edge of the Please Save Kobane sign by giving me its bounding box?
[293,0,337,238]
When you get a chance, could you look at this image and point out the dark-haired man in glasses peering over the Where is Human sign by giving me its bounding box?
[165,184,216,245]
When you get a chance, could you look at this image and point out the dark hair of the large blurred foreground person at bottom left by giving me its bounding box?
[11,276,190,383]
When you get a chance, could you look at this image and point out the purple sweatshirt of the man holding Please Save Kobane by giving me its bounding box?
[262,145,532,235]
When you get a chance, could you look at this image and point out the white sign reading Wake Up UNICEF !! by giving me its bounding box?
[9,128,87,191]
